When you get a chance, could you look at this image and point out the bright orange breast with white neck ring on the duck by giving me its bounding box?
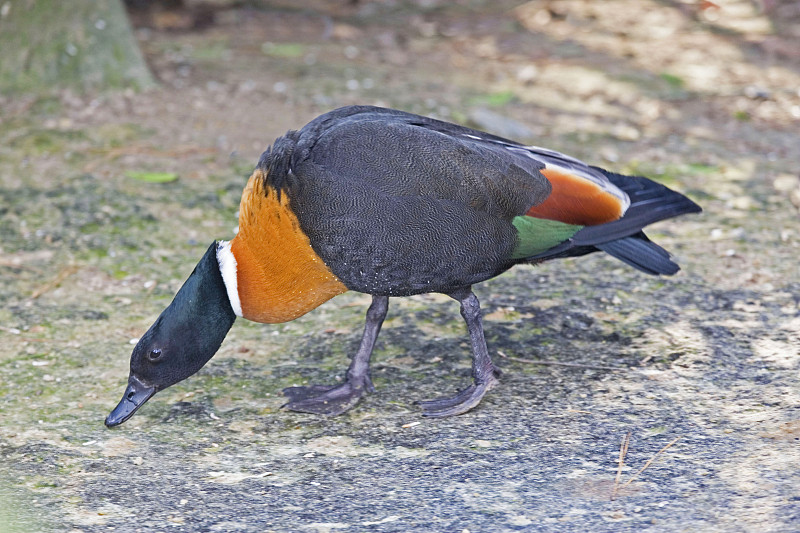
[217,170,347,323]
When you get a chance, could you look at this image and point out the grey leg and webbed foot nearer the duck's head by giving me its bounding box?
[283,296,389,416]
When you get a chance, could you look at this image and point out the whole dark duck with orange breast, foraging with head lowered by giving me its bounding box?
[105,106,701,427]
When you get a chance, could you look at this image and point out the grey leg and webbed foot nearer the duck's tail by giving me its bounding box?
[419,287,498,416]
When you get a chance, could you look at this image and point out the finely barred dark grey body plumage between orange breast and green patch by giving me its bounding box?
[278,106,564,295]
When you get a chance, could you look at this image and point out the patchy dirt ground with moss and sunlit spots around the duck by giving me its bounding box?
[0,0,800,533]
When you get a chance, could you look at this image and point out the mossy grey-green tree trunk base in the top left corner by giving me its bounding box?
[0,0,154,93]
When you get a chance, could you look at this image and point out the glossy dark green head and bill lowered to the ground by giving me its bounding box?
[106,243,236,427]
